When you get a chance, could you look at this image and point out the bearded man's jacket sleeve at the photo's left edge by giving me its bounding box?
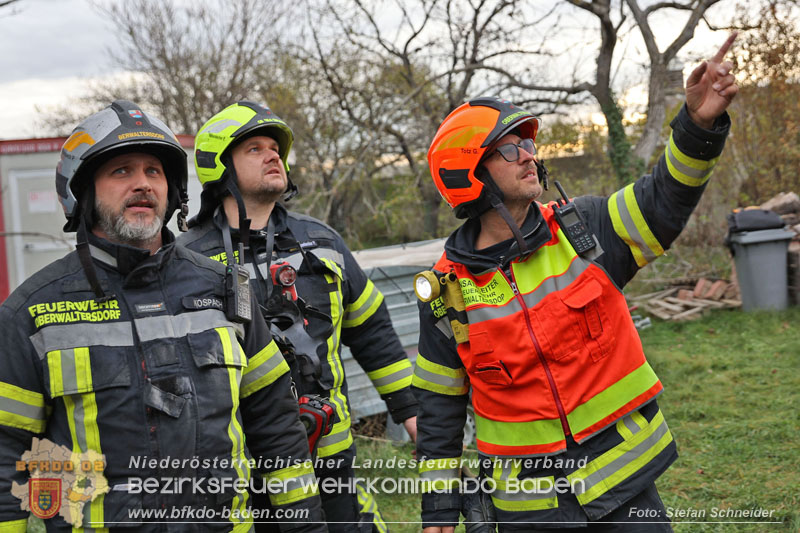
[0,305,50,533]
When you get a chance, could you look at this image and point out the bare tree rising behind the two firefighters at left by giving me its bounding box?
[79,0,288,133]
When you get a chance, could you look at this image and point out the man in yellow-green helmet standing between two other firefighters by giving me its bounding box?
[179,101,416,532]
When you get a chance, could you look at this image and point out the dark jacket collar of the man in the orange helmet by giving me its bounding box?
[444,202,552,274]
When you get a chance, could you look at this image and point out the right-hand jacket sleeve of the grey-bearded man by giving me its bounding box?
[240,302,327,531]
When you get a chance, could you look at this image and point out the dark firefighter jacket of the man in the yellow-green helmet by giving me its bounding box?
[179,204,417,461]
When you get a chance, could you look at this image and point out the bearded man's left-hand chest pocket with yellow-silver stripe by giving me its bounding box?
[45,346,131,398]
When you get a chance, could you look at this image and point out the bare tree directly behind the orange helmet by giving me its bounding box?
[312,0,560,238]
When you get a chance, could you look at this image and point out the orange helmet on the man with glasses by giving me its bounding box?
[428,97,539,218]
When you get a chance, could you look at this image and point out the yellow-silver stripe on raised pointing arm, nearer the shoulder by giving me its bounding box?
[608,184,664,267]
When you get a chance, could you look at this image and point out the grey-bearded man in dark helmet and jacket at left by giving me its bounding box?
[0,100,326,533]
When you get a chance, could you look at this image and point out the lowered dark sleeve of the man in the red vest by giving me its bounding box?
[412,299,469,528]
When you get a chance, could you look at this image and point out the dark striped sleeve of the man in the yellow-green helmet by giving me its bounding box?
[341,242,417,423]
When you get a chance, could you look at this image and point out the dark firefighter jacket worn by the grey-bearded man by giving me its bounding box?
[0,230,326,532]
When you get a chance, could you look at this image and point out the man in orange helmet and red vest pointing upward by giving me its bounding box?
[412,35,738,533]
